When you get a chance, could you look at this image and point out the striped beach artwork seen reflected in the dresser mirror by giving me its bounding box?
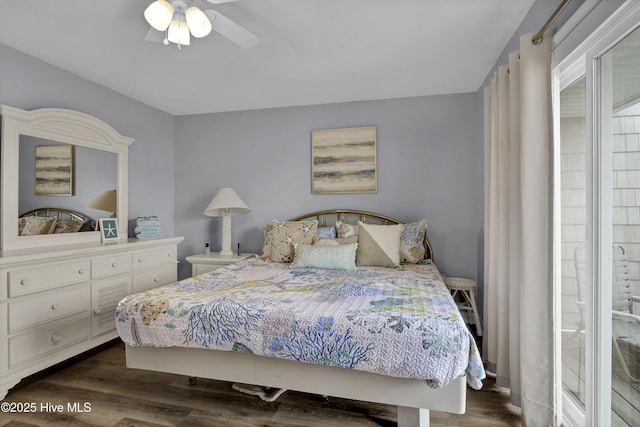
[35,144,74,196]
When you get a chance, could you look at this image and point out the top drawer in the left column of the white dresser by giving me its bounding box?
[8,259,90,297]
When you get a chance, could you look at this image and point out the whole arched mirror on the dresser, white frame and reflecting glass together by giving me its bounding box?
[0,105,133,251]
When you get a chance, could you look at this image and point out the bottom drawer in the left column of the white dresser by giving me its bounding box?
[9,317,91,366]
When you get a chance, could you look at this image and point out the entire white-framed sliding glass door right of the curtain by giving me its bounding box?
[554,2,640,427]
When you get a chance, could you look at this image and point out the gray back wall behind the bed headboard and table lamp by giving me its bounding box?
[175,94,483,279]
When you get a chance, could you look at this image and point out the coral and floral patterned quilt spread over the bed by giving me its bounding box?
[116,259,485,389]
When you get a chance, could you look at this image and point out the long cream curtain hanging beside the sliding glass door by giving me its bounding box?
[483,34,559,427]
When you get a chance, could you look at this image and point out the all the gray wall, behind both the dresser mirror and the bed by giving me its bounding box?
[0,40,482,290]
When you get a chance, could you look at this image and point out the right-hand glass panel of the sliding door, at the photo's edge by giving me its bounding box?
[597,25,640,426]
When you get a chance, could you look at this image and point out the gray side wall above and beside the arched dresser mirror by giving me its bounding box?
[0,45,175,236]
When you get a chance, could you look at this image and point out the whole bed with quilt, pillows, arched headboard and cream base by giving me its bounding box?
[116,210,485,426]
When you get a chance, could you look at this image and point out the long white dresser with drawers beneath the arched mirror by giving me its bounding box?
[0,237,182,400]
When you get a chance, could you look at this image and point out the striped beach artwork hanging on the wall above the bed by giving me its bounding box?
[311,126,378,194]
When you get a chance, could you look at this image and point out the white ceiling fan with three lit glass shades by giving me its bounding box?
[144,0,260,49]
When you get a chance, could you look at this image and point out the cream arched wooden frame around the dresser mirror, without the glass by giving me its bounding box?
[0,105,134,251]
